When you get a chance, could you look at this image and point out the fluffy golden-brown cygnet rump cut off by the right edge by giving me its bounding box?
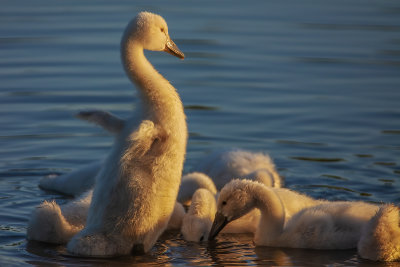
[358,205,400,261]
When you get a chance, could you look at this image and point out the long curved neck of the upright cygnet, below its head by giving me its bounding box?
[121,39,183,122]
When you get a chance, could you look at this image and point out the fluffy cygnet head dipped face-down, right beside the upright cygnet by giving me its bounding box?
[181,188,216,242]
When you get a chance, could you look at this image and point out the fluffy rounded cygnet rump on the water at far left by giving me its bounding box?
[27,200,82,244]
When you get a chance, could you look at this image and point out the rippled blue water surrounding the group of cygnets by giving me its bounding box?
[0,0,400,266]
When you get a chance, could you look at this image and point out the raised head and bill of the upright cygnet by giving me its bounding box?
[121,12,185,59]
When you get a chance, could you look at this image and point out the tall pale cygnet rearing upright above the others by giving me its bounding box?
[67,12,187,256]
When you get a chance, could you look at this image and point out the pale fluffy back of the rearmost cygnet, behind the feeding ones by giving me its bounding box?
[193,149,284,190]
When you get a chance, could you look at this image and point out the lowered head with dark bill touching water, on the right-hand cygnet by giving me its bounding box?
[208,179,261,240]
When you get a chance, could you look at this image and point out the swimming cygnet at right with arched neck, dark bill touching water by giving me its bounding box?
[209,180,379,249]
